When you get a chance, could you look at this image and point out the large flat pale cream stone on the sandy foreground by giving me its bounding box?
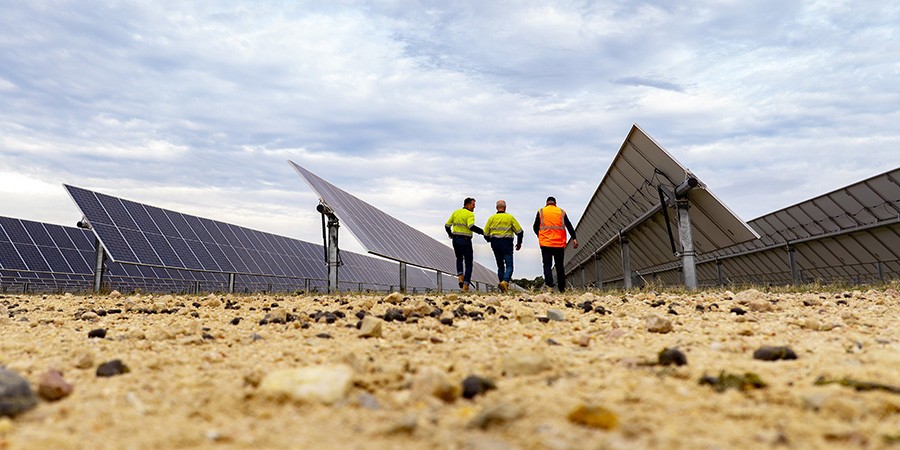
[259,364,353,404]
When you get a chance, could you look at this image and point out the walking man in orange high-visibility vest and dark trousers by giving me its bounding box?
[533,197,578,292]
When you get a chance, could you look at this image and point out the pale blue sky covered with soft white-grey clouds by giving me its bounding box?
[0,0,900,278]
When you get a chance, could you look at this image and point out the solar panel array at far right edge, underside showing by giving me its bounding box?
[648,168,900,285]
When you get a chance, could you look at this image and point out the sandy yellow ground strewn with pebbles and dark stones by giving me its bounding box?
[0,286,900,450]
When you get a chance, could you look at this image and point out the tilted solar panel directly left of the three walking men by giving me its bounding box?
[288,161,497,288]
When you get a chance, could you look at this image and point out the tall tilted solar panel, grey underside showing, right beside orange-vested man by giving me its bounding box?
[565,125,758,286]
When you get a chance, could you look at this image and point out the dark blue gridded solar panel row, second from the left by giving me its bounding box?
[65,185,435,290]
